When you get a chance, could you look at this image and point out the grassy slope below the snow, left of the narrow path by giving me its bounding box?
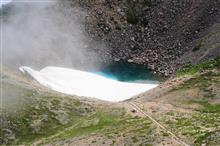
[0,70,168,146]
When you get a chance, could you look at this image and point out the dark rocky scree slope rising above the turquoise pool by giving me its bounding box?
[75,0,220,76]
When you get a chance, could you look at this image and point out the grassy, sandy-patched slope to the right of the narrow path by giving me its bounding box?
[137,57,220,146]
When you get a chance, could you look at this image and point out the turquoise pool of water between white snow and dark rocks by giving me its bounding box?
[96,62,159,82]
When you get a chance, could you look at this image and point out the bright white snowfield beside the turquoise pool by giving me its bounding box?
[19,66,157,102]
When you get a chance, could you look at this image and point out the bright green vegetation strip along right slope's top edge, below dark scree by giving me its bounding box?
[176,57,220,76]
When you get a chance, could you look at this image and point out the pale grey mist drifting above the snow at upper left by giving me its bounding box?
[1,0,103,69]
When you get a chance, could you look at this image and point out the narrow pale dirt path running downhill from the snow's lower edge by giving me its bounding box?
[128,102,189,146]
